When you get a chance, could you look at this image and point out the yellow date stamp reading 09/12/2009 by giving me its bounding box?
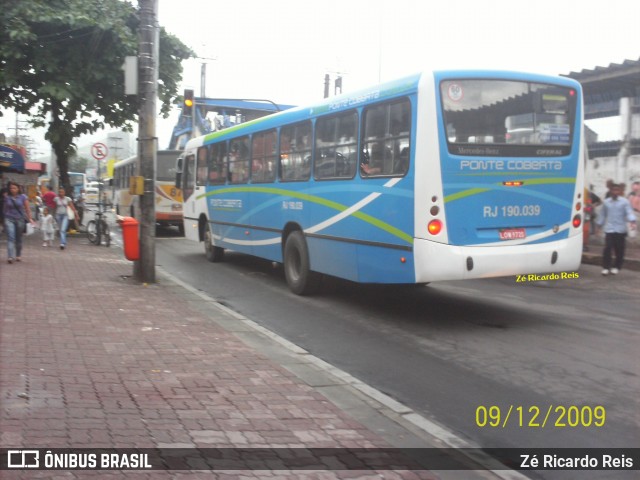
[476,405,607,428]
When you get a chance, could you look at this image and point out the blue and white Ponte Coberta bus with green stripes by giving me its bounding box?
[176,71,584,294]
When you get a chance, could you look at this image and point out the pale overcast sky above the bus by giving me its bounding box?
[6,0,640,156]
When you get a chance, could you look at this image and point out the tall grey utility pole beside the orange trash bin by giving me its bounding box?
[133,0,159,283]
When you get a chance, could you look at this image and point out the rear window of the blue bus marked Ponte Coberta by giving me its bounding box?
[440,79,577,157]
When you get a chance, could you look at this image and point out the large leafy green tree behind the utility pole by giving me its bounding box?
[0,0,194,195]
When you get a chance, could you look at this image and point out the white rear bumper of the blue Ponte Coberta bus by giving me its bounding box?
[414,235,582,283]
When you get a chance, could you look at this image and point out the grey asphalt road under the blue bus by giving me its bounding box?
[156,231,640,478]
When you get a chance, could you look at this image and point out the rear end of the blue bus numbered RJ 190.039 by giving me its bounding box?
[414,72,584,282]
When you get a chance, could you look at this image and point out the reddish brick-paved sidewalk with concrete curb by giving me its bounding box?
[0,234,495,479]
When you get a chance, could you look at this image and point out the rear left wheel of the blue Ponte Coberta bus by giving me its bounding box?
[284,231,322,295]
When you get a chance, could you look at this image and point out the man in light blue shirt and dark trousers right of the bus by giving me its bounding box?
[598,183,636,275]
